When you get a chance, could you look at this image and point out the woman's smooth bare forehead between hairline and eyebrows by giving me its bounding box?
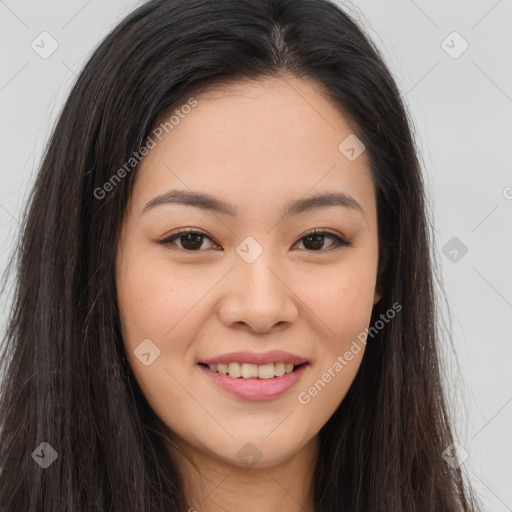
[130,77,375,226]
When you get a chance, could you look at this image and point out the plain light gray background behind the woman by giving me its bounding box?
[0,0,512,512]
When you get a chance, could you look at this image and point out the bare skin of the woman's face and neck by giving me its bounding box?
[116,77,381,512]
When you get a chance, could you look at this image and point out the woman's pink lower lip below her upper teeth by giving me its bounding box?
[199,363,307,400]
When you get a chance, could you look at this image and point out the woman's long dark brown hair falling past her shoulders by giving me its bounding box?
[0,0,478,512]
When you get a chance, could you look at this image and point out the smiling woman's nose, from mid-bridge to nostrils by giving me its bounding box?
[219,251,298,333]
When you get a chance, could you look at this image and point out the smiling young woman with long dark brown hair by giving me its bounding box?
[0,0,477,512]
